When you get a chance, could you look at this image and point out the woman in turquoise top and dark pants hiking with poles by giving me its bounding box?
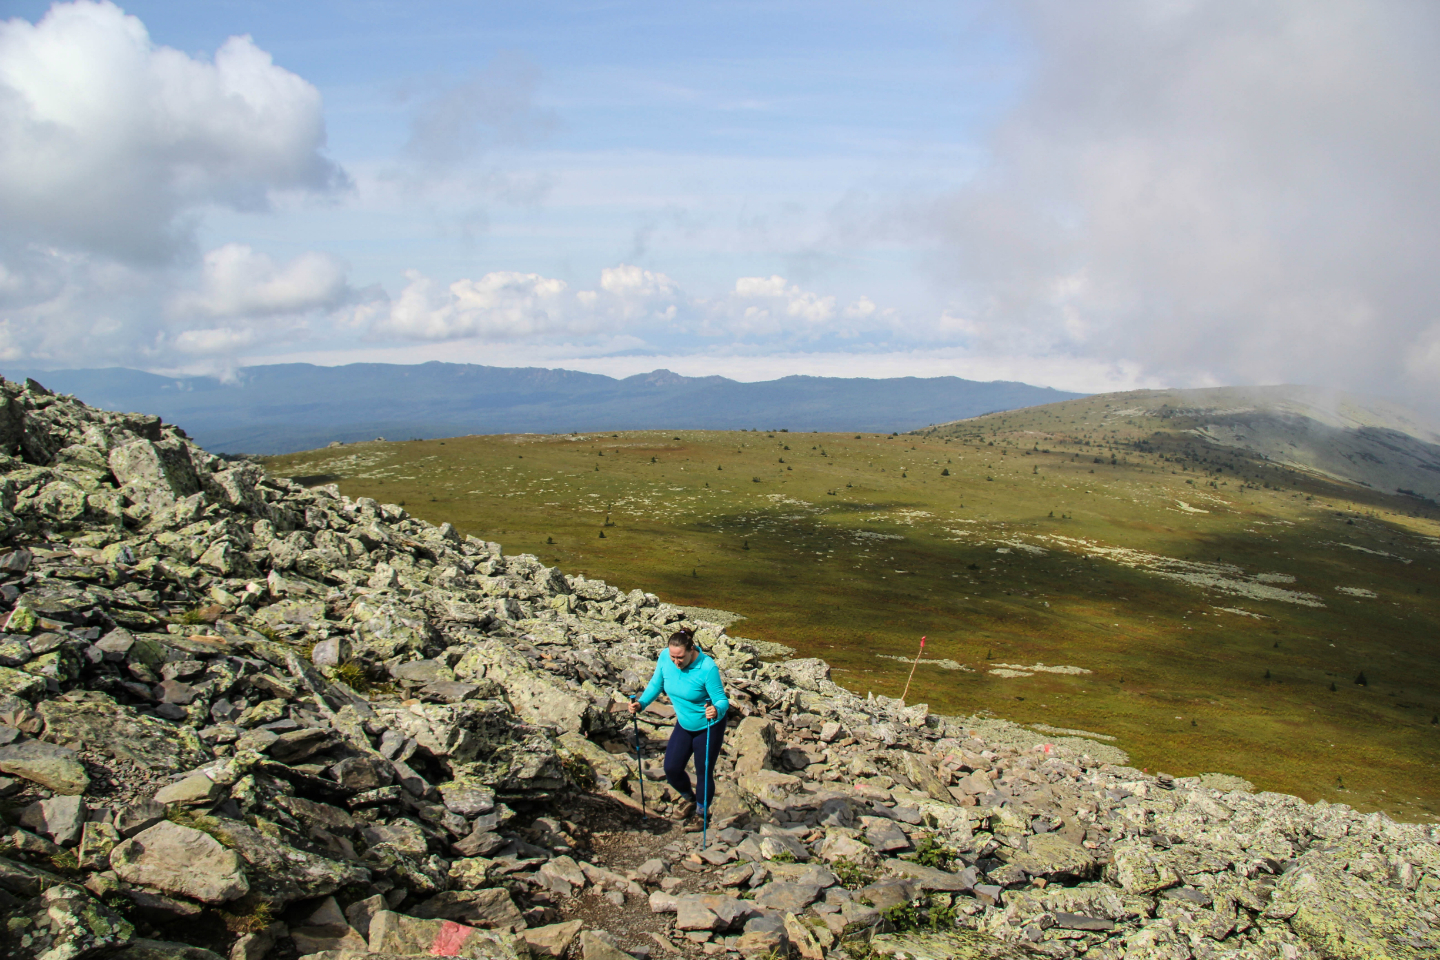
[629,628,730,820]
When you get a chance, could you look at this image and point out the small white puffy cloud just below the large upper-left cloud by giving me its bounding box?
[170,243,350,320]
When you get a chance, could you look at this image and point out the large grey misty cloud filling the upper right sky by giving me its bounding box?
[892,0,1440,406]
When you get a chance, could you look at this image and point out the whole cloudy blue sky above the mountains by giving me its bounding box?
[0,0,1440,406]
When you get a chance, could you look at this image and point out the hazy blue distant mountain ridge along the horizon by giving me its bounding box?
[0,361,1083,453]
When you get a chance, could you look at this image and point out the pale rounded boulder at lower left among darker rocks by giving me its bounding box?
[109,820,251,904]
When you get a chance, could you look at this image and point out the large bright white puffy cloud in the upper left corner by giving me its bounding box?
[0,1,346,263]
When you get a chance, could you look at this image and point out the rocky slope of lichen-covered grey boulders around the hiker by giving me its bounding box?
[0,383,1440,960]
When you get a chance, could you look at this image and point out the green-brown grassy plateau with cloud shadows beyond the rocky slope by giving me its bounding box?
[268,397,1440,820]
